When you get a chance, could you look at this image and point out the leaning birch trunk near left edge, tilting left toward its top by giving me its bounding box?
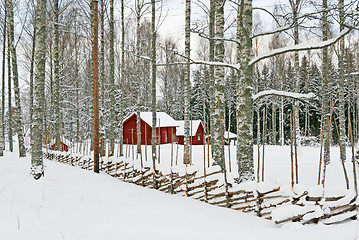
[6,0,26,157]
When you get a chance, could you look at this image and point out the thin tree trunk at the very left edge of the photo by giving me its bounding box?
[0,8,7,152]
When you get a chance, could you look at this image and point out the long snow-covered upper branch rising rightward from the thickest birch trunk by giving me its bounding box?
[249,28,351,65]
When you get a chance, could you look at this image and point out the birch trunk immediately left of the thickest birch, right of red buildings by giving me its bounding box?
[212,0,225,170]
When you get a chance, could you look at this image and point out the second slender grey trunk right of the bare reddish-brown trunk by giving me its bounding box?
[109,0,117,156]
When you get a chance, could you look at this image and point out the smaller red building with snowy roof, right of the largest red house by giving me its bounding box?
[177,120,205,145]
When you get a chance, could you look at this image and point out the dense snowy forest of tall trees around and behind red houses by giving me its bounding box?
[0,0,359,181]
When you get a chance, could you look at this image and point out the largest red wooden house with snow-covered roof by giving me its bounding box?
[123,112,178,145]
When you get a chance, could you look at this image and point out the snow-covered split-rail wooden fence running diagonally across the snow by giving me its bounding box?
[44,151,358,224]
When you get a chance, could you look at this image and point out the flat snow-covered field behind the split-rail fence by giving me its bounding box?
[119,144,353,193]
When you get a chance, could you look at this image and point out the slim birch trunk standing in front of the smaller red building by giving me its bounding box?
[183,0,191,164]
